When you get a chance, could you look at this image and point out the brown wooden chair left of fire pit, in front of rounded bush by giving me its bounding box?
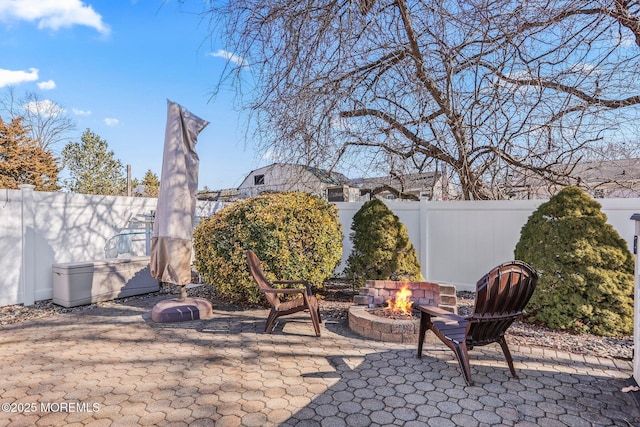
[247,250,322,337]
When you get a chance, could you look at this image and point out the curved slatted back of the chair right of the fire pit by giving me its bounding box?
[467,261,538,346]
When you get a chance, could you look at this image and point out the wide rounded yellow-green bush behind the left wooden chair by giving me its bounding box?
[193,192,342,304]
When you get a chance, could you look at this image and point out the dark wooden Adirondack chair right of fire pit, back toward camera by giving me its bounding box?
[418,261,538,385]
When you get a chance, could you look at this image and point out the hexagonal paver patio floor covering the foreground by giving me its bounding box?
[0,296,640,427]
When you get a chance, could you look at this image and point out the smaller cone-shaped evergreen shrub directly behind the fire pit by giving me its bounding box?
[344,199,424,286]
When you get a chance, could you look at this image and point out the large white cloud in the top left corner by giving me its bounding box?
[0,0,110,35]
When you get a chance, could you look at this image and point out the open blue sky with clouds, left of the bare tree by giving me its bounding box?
[0,0,270,189]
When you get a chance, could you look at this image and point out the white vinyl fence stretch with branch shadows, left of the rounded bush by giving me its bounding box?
[0,186,228,307]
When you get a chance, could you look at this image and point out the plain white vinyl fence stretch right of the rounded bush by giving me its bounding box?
[336,199,640,290]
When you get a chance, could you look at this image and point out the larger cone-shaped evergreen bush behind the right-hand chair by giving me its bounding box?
[515,187,634,336]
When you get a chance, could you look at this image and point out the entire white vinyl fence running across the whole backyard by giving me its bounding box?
[0,186,640,306]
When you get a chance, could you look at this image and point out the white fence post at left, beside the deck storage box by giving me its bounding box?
[18,184,36,306]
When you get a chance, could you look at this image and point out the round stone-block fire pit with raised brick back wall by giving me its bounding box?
[349,280,457,343]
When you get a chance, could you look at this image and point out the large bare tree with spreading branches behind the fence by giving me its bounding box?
[202,0,640,199]
